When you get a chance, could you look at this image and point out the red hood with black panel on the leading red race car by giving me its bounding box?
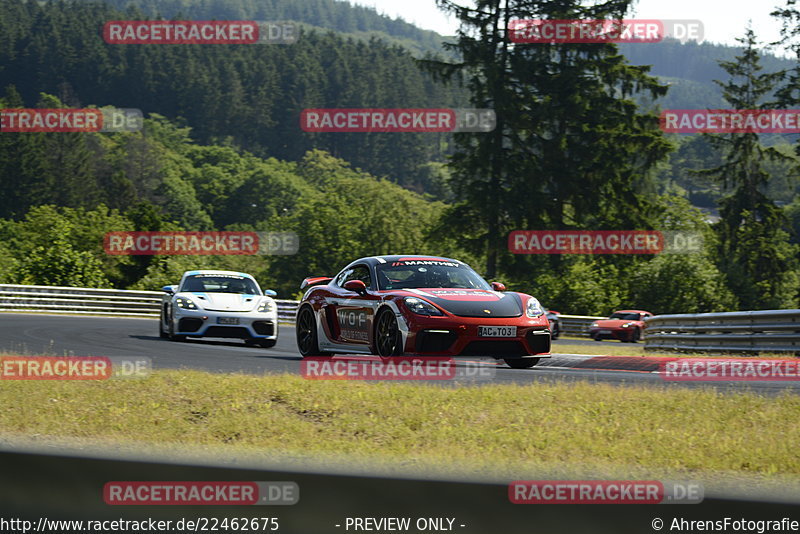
[404,288,523,318]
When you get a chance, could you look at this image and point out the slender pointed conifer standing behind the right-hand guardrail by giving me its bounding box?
[699,28,800,309]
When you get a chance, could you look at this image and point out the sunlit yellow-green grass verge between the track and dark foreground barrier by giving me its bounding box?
[0,371,800,490]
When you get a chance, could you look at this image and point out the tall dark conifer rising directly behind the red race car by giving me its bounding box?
[423,0,671,278]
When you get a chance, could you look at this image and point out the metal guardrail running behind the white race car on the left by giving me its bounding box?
[0,284,297,323]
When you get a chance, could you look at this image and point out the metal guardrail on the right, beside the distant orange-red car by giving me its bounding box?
[645,310,800,353]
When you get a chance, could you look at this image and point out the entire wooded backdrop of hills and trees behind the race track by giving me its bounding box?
[0,0,800,314]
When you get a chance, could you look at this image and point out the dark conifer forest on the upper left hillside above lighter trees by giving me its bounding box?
[0,0,466,194]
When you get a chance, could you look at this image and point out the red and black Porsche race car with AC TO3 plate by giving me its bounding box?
[296,256,550,369]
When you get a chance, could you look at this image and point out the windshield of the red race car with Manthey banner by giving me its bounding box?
[376,262,492,291]
